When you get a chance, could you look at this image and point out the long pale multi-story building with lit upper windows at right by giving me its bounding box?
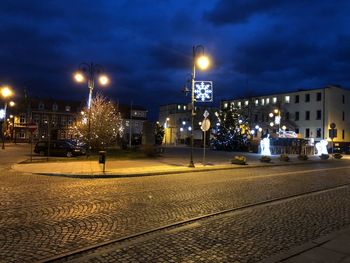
[221,86,350,142]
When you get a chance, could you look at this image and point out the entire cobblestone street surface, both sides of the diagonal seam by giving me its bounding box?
[0,145,350,262]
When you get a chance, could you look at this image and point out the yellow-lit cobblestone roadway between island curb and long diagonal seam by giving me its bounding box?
[0,158,350,262]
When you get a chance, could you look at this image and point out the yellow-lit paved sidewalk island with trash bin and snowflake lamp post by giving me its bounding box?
[12,153,332,178]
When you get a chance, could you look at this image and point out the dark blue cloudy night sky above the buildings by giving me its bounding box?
[0,0,350,118]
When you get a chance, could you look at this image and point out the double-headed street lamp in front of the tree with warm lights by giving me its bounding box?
[74,62,109,157]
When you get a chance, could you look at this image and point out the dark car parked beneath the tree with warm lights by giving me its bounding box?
[34,140,86,157]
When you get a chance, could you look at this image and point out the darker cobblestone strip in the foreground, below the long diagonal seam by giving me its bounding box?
[61,187,350,263]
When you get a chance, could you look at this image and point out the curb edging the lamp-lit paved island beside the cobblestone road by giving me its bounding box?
[32,160,325,179]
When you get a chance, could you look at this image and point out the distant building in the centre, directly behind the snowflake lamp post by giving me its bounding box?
[159,103,218,144]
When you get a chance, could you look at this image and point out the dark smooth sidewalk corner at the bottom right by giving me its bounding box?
[259,227,350,263]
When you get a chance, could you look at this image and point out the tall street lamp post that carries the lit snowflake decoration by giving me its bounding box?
[188,45,210,167]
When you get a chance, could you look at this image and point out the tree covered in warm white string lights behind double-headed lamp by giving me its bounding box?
[74,94,123,149]
